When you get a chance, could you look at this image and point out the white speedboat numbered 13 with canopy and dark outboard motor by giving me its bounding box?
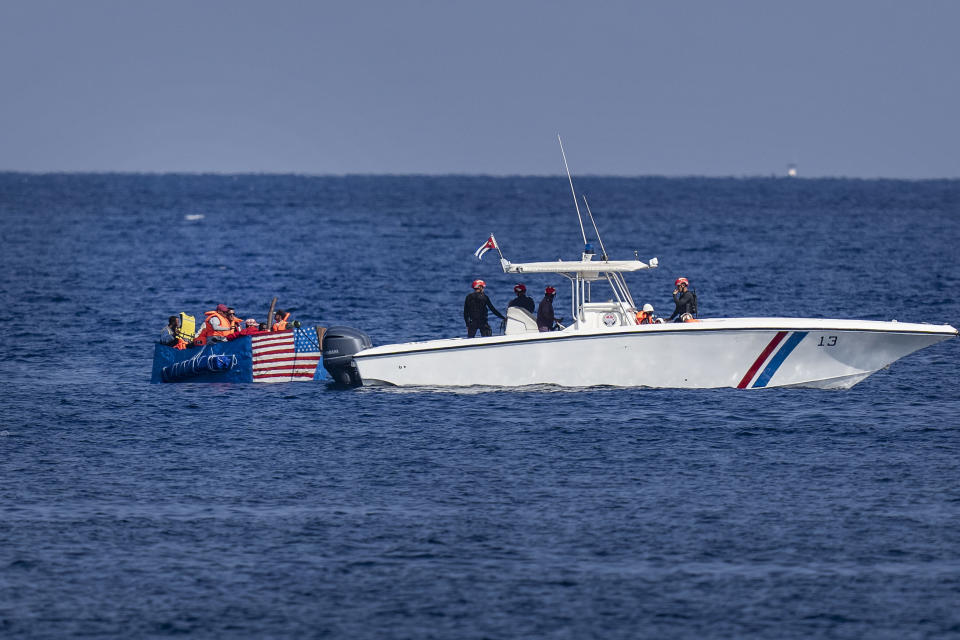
[324,253,957,389]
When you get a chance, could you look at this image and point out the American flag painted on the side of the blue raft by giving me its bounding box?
[251,329,321,382]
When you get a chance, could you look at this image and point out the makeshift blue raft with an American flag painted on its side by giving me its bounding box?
[150,327,327,383]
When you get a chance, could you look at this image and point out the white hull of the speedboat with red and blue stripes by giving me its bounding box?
[355,318,957,389]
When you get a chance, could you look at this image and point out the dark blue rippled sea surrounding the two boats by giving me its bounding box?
[0,173,960,640]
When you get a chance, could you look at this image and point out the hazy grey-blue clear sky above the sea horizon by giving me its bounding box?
[0,0,960,179]
